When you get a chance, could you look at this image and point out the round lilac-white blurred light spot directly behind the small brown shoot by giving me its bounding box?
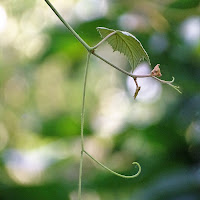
[127,63,162,103]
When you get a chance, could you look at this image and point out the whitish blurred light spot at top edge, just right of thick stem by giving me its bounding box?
[75,0,108,21]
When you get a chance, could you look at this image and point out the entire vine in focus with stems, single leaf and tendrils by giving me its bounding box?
[45,0,181,200]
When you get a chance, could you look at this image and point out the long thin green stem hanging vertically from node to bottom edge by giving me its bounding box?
[78,53,91,200]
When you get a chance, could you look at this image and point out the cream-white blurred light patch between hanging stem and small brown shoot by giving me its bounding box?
[92,89,129,137]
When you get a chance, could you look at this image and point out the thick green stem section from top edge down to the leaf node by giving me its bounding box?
[45,0,92,52]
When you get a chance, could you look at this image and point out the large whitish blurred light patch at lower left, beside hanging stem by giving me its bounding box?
[3,140,74,184]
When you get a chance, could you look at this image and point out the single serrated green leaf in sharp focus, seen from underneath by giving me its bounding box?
[97,27,151,70]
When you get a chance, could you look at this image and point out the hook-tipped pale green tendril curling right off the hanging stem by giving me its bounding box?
[83,150,141,178]
